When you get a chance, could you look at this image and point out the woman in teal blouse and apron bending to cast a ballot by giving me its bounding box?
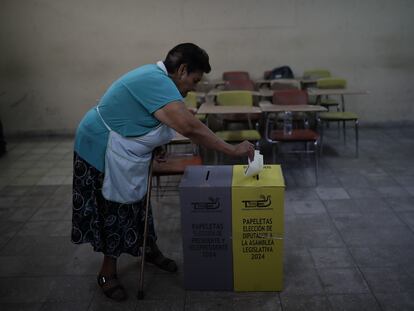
[72,43,254,301]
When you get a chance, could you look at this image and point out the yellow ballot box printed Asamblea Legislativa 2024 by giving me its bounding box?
[232,165,285,291]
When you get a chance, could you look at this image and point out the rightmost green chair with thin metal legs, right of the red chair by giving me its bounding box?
[317,78,359,157]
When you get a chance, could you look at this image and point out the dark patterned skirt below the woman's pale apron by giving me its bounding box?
[71,152,156,258]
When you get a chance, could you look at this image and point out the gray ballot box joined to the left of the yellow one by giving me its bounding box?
[180,165,233,290]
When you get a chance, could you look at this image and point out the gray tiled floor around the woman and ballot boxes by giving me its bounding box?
[0,128,414,311]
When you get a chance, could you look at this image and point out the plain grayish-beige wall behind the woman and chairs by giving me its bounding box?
[0,0,414,135]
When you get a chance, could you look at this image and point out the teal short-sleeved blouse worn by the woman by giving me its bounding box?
[74,64,183,172]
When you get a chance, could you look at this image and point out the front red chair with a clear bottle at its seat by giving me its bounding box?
[265,89,320,184]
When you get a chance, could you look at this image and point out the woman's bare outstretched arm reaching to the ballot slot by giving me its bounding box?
[154,101,254,160]
